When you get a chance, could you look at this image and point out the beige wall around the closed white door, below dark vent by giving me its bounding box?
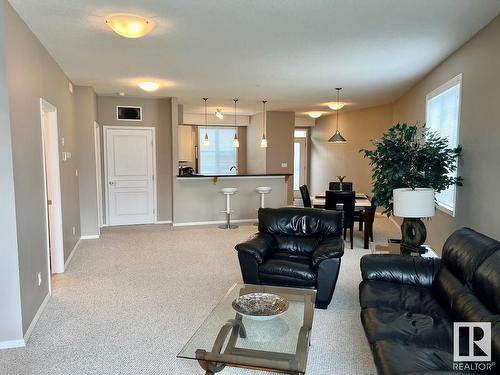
[97,96,173,221]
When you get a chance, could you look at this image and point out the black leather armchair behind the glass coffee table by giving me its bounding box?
[236,207,344,309]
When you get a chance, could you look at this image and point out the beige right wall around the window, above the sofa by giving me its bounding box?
[393,17,500,254]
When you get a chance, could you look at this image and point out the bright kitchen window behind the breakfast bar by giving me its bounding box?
[198,126,238,174]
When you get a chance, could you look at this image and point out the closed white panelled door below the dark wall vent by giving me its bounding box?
[104,127,155,225]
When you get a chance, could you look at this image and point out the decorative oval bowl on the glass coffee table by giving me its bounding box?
[232,293,288,320]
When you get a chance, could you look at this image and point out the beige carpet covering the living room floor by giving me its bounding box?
[0,218,398,375]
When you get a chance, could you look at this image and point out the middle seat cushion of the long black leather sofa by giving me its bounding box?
[361,308,453,351]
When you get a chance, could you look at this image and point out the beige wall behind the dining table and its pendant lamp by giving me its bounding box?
[310,105,392,195]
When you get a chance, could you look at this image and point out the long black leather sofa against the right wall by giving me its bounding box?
[359,228,500,374]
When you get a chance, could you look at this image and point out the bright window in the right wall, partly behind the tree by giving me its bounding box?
[426,74,462,216]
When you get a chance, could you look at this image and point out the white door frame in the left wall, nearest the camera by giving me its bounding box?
[40,98,64,276]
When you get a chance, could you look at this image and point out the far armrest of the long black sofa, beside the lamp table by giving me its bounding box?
[361,254,441,287]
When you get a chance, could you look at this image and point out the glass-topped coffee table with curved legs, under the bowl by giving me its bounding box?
[177,284,316,375]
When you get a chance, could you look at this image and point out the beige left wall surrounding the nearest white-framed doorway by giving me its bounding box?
[1,0,80,332]
